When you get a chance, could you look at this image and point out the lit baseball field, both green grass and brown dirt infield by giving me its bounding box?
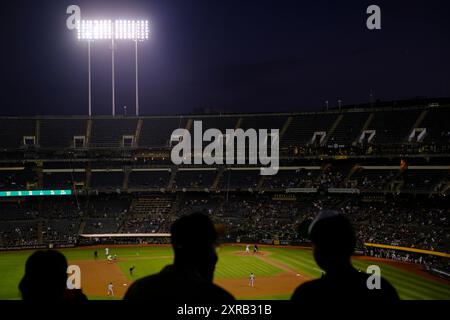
[0,245,450,300]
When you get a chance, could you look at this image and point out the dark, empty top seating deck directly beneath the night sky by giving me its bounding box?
[0,105,450,151]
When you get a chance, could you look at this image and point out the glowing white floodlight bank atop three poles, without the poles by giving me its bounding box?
[77,20,149,41]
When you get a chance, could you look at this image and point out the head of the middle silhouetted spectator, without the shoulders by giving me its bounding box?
[170,213,217,281]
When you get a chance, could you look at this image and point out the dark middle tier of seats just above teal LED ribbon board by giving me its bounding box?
[0,164,450,192]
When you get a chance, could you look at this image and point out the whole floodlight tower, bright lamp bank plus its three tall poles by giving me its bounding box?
[77,19,149,116]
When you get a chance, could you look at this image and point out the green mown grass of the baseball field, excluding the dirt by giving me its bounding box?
[0,246,450,300]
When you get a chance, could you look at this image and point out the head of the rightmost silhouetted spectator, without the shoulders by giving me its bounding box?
[309,210,356,272]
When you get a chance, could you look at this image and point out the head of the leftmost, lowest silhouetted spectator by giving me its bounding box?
[19,250,67,301]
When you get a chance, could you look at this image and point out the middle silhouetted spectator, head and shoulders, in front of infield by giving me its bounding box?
[124,213,234,302]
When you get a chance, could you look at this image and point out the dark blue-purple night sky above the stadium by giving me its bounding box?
[0,0,450,115]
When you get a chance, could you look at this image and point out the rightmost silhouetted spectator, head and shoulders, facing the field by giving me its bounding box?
[291,210,399,303]
